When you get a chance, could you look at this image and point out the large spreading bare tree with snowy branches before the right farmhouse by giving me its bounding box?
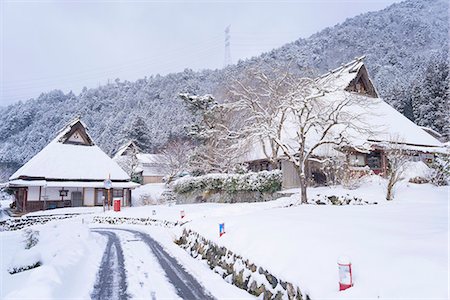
[230,70,375,203]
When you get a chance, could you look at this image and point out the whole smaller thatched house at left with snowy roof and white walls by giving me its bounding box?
[8,118,139,212]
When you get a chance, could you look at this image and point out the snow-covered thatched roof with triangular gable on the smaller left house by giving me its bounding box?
[10,118,130,181]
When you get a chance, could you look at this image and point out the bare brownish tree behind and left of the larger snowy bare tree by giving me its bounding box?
[227,66,297,166]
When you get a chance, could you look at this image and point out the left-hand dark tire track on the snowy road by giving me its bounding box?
[91,230,129,300]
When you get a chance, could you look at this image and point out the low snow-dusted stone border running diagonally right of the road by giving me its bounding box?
[175,229,310,300]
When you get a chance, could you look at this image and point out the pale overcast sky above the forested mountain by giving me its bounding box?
[0,0,399,106]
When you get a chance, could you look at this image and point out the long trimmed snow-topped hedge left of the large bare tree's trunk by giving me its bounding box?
[172,170,282,194]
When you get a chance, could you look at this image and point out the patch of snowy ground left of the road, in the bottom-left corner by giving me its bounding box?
[0,218,105,299]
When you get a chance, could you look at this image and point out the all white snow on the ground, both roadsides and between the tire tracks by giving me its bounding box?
[0,180,449,299]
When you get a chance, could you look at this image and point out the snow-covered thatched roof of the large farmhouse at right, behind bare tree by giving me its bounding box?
[243,57,447,161]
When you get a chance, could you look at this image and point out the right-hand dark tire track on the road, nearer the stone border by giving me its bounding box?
[94,228,214,300]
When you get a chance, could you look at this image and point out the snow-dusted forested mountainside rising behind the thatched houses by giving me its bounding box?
[0,0,449,181]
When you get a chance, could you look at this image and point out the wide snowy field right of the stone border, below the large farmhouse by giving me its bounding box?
[99,180,449,299]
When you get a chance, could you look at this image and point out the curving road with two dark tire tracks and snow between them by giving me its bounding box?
[91,228,214,300]
